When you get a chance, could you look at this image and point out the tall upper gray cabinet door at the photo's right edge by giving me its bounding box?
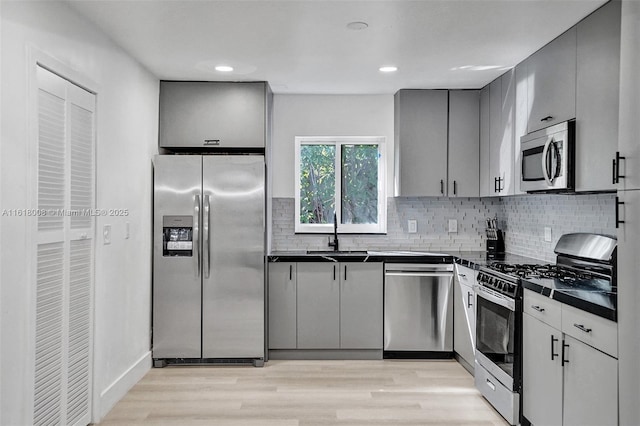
[618,1,640,191]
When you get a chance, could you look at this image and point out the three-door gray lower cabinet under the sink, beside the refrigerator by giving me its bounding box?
[269,262,383,350]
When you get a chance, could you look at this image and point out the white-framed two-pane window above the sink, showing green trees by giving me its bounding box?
[295,136,387,233]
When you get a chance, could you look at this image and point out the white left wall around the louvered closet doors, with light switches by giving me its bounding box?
[0,1,158,425]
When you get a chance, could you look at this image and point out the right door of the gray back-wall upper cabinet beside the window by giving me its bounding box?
[447,90,480,197]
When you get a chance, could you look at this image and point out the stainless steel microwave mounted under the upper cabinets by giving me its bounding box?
[520,120,575,192]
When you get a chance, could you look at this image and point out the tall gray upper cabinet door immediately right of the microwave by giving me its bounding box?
[575,1,621,191]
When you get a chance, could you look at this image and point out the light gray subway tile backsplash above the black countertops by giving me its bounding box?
[271,194,615,262]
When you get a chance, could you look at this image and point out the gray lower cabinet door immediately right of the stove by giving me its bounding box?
[522,313,564,425]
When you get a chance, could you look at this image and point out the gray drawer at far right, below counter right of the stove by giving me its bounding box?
[562,305,618,358]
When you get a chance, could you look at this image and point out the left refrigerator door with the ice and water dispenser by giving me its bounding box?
[152,155,202,358]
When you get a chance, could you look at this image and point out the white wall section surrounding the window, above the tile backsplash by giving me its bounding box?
[271,95,393,198]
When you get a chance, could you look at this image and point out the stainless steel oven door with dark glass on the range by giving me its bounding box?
[476,286,517,390]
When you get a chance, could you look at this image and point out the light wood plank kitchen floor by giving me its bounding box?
[101,360,507,426]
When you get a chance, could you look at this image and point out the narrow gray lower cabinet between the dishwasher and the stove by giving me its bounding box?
[453,264,478,370]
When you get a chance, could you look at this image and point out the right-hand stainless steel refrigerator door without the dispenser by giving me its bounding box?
[202,155,265,358]
